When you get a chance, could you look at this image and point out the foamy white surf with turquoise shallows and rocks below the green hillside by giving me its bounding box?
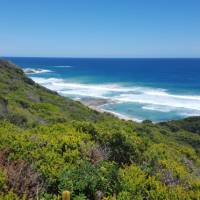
[26,68,200,123]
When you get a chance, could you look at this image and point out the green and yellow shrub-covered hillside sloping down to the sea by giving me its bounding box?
[0,61,200,200]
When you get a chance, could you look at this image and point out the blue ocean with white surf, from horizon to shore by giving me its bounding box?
[7,58,200,122]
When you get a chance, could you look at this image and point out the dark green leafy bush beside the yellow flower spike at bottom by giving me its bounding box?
[59,161,118,199]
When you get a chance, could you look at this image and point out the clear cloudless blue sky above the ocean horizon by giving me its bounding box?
[0,0,200,57]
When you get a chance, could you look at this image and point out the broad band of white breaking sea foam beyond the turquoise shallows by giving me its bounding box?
[32,77,200,119]
